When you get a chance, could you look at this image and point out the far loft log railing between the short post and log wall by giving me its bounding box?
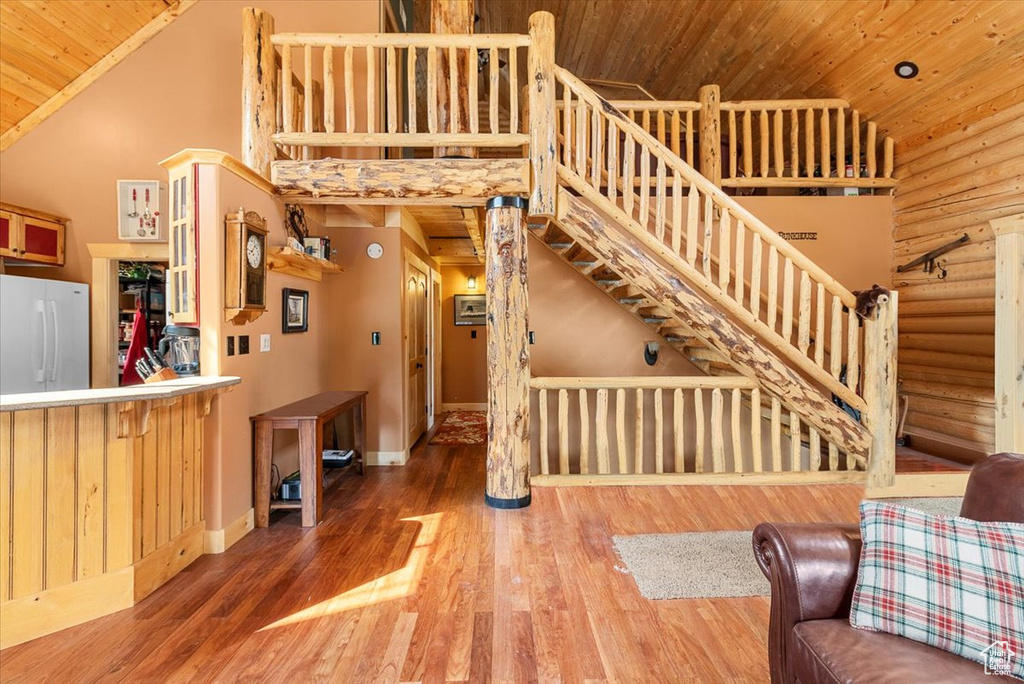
[720,99,895,187]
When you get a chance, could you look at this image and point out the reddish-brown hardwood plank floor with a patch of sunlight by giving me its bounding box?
[0,423,862,683]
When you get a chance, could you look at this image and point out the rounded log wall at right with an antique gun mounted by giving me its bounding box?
[893,89,1024,462]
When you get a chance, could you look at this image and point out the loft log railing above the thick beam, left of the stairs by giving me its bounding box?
[271,34,529,147]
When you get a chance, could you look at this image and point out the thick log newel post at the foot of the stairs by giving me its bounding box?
[863,292,899,487]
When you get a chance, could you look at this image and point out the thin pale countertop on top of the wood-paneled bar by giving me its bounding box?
[0,376,242,412]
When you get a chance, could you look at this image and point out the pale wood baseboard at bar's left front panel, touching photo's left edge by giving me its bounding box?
[0,567,135,648]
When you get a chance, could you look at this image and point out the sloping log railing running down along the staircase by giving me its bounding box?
[556,69,865,411]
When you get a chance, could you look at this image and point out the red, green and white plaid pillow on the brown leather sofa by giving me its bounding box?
[850,502,1024,679]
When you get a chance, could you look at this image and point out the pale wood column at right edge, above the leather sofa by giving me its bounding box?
[989,214,1024,454]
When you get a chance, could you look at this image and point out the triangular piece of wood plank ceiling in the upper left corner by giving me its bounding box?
[0,0,195,148]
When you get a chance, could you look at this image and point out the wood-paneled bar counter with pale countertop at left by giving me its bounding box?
[0,377,241,648]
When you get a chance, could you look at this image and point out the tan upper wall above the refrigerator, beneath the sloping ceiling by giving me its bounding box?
[0,0,380,282]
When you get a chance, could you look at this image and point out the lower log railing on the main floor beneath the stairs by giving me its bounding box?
[530,377,866,481]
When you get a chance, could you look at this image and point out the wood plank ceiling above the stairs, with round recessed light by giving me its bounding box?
[476,0,1024,141]
